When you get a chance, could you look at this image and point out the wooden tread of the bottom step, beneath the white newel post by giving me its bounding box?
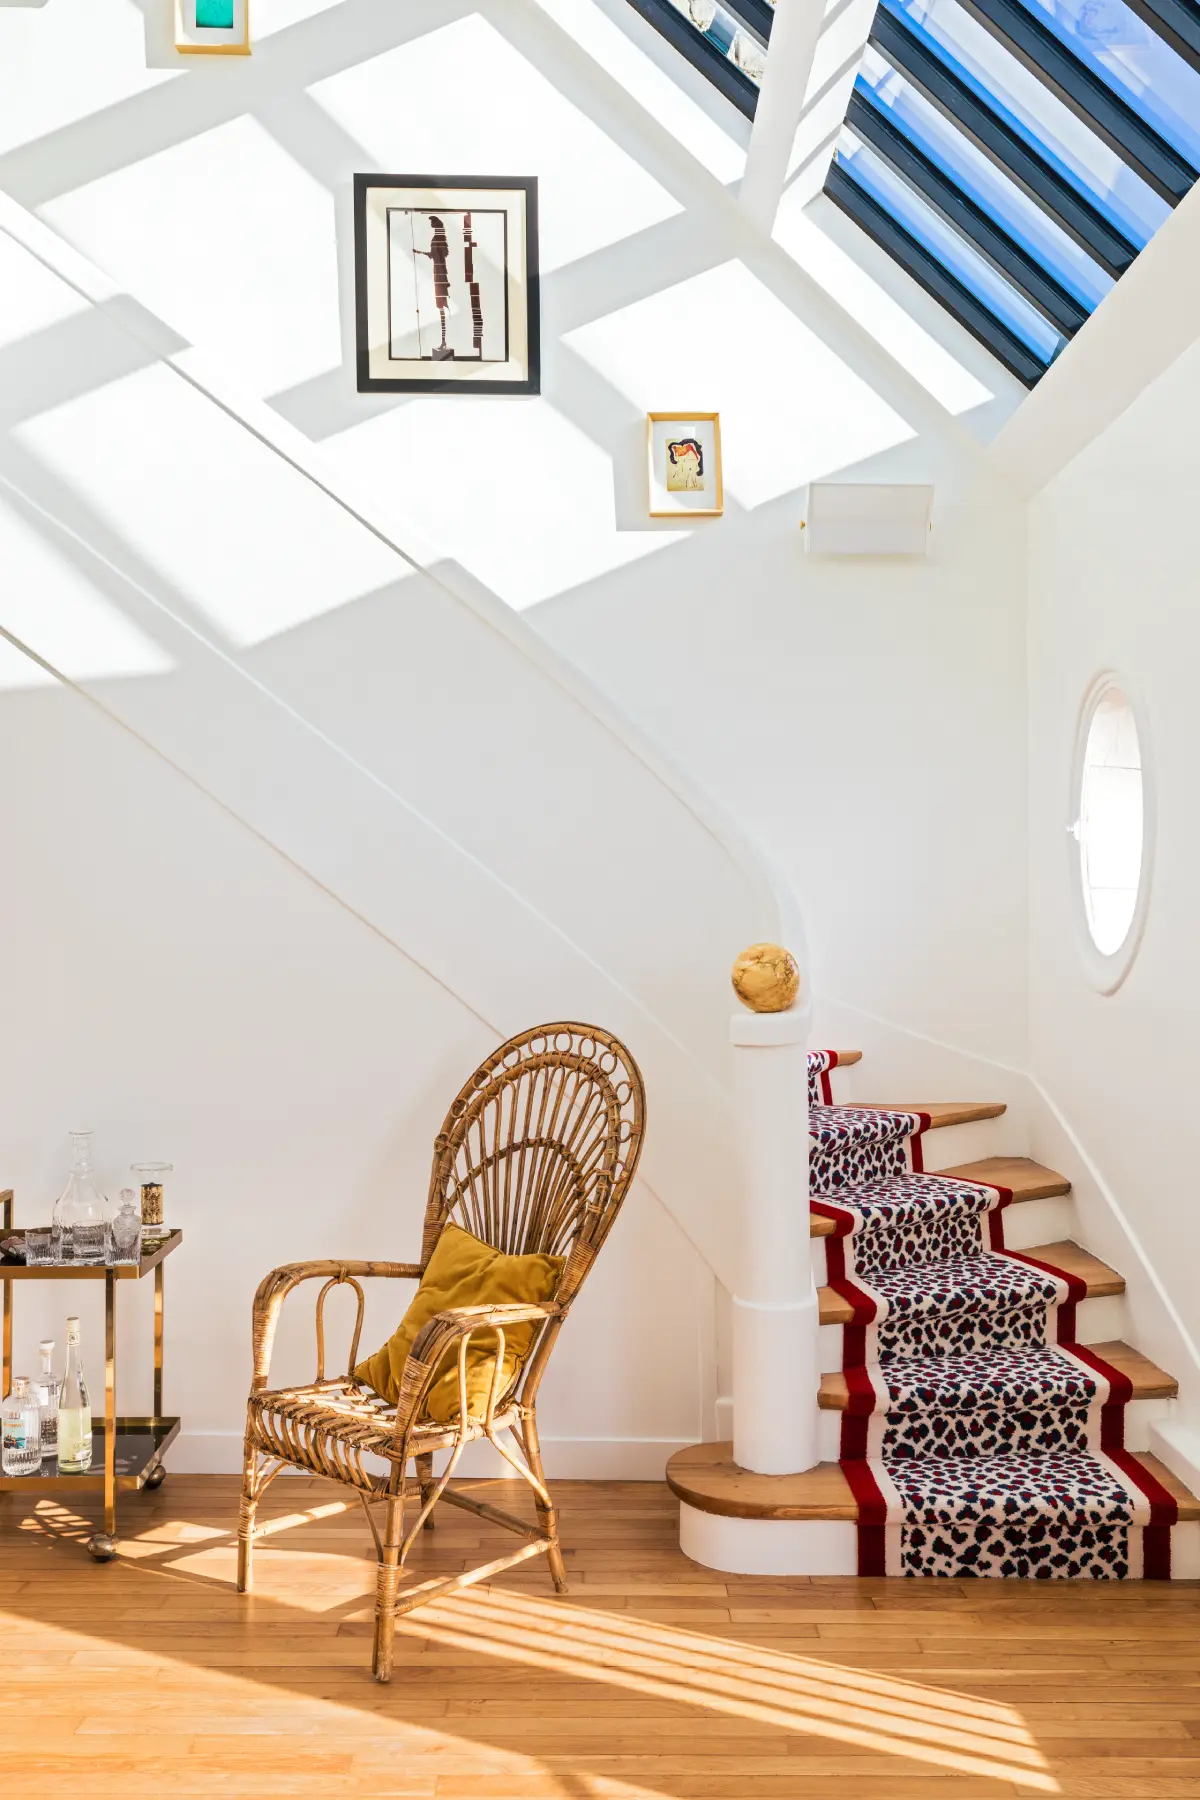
[667,1442,1200,1519]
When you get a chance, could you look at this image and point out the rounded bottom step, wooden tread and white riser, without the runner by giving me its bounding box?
[667,1444,1200,1580]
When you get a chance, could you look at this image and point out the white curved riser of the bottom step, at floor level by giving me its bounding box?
[680,1503,1200,1580]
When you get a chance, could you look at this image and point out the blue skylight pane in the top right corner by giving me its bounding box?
[1022,0,1200,169]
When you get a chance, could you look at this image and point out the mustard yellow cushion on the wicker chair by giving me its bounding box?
[354,1226,567,1426]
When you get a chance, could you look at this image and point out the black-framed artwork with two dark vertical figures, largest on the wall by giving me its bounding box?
[354,175,542,394]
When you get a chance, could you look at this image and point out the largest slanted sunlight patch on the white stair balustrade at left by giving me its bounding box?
[13,365,412,646]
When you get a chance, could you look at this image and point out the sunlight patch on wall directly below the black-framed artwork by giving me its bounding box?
[326,398,678,612]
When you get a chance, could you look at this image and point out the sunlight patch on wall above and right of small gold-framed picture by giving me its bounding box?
[567,261,914,508]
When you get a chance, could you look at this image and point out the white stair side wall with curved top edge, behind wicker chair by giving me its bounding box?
[0,211,779,1474]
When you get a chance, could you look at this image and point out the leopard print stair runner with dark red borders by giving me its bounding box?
[810,1064,1177,1579]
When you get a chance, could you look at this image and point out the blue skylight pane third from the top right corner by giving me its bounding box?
[858,49,1112,311]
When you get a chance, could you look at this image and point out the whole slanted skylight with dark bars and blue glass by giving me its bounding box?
[631,0,1200,385]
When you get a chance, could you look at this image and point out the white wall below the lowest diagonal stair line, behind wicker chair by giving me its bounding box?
[0,646,712,1476]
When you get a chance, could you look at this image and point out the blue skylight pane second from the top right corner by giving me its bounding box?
[883,0,1171,250]
